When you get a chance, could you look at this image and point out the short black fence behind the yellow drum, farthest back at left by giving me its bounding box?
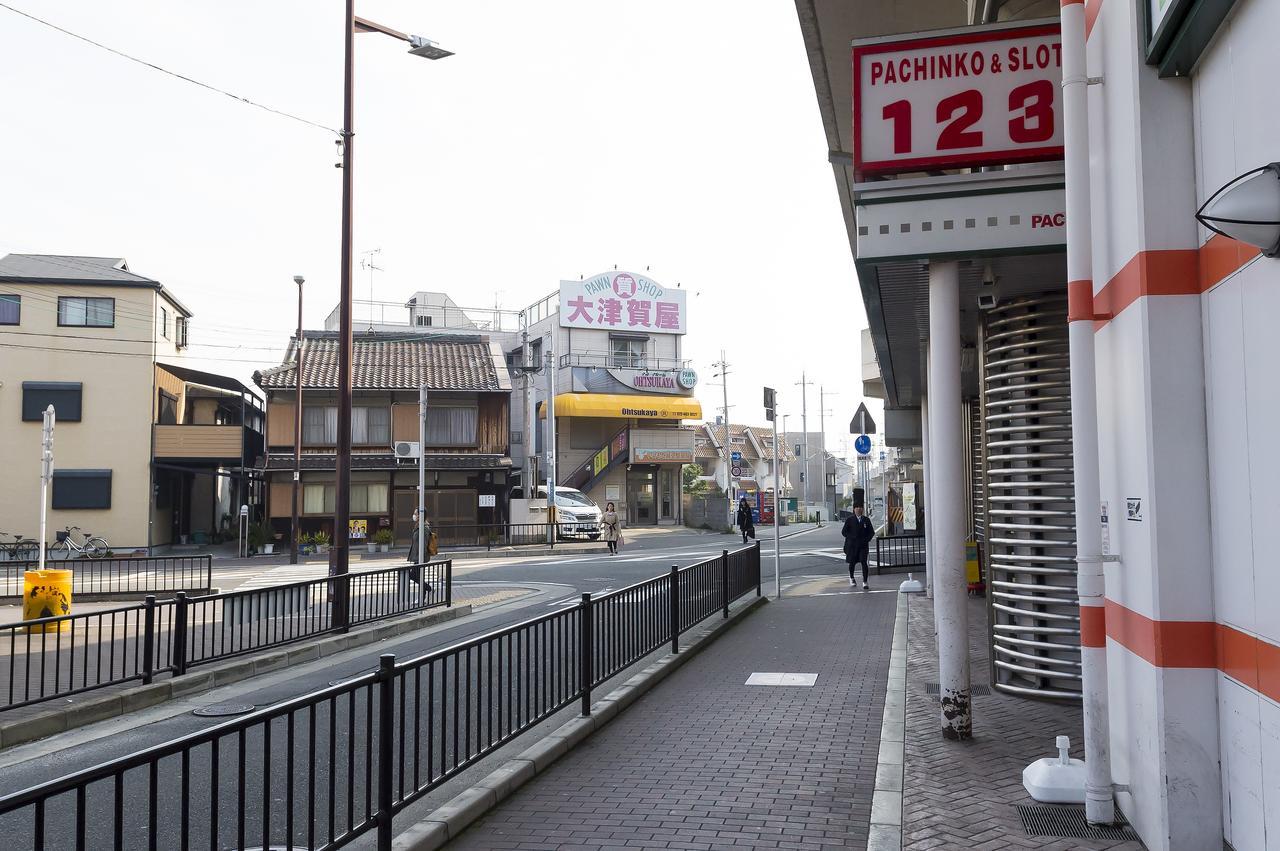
[0,555,214,598]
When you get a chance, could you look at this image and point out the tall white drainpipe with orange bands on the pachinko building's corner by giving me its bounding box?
[1062,0,1115,824]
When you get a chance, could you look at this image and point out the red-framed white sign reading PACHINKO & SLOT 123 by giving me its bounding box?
[854,22,1062,174]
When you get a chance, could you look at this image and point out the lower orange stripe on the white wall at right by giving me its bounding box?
[1105,600,1280,703]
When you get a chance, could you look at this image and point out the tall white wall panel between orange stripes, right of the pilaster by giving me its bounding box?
[1203,279,1256,632]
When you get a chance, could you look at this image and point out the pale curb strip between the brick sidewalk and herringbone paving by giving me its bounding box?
[867,591,910,851]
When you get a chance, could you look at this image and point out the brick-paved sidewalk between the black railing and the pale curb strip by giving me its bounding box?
[449,578,897,851]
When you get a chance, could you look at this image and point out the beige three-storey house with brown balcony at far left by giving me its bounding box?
[0,255,262,552]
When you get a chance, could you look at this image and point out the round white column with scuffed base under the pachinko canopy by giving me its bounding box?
[927,261,973,738]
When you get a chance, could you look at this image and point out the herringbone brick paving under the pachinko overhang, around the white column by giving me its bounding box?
[902,595,1143,851]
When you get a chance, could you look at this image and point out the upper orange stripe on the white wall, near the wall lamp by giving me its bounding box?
[1090,234,1262,330]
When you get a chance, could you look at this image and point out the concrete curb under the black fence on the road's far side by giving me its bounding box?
[0,605,471,750]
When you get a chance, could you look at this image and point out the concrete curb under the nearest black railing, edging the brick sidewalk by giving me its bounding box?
[392,596,768,851]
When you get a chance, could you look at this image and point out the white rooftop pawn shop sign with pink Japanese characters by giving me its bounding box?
[559,271,686,334]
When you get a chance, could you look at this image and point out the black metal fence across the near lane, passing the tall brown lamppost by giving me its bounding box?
[0,561,453,712]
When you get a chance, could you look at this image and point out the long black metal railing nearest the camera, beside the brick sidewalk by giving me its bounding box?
[0,545,760,851]
